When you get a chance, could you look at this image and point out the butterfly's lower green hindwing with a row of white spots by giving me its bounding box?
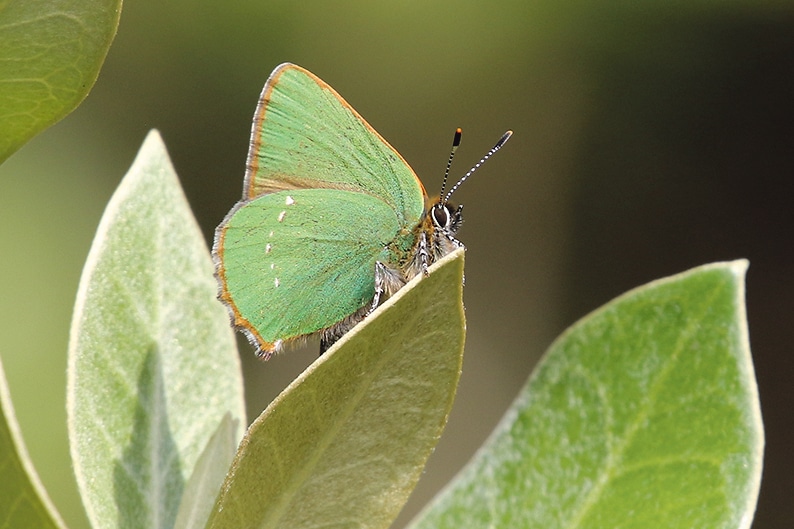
[215,189,413,355]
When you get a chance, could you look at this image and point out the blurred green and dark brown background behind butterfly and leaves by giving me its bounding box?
[0,0,794,529]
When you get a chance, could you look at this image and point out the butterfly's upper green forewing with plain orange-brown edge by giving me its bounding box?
[244,64,426,226]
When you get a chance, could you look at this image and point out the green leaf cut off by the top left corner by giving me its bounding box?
[0,0,121,163]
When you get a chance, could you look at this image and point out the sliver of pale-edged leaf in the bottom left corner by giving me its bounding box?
[0,354,66,529]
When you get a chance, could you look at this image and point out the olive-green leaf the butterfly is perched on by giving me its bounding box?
[207,250,465,529]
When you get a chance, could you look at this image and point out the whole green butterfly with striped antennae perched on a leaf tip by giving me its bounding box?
[212,64,511,359]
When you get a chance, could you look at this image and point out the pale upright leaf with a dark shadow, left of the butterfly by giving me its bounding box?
[67,131,245,529]
